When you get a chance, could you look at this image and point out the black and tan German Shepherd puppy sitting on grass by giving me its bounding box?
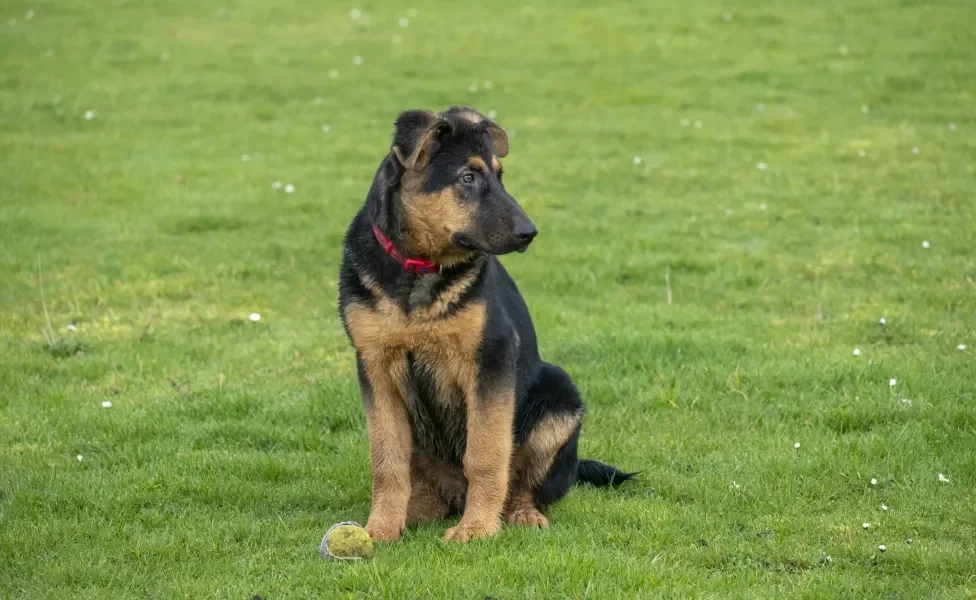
[339,107,633,542]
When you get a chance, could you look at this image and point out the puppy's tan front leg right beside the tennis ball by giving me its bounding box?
[360,362,413,542]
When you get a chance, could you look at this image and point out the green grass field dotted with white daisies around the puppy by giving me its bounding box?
[0,0,976,600]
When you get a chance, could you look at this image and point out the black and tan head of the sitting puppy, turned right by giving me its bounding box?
[391,107,537,261]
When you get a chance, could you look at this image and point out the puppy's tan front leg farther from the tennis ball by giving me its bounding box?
[444,386,515,542]
